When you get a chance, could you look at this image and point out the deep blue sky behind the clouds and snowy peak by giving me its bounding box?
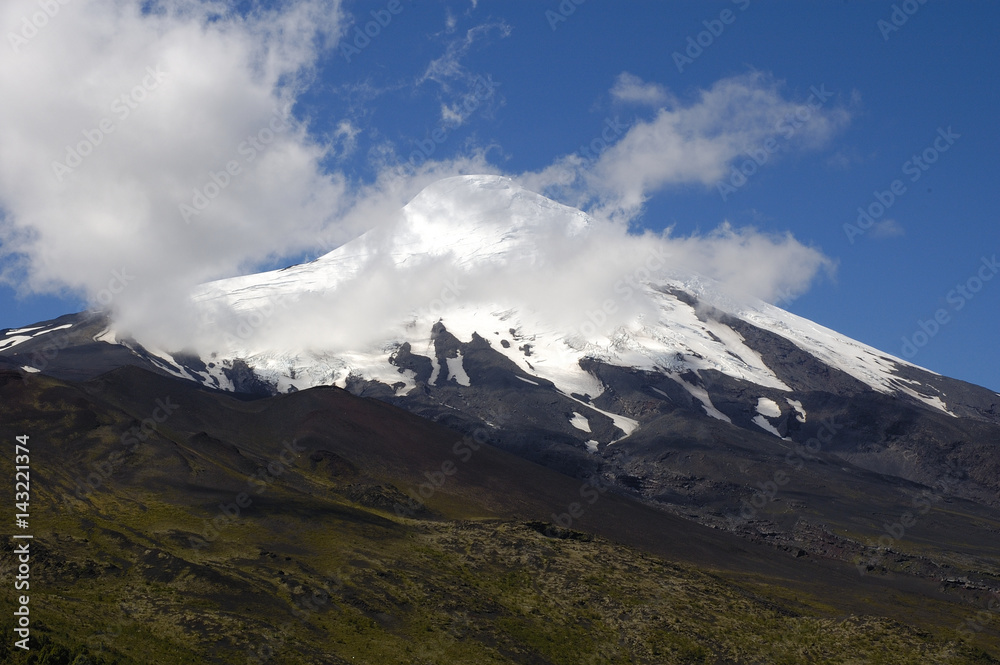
[0,0,1000,390]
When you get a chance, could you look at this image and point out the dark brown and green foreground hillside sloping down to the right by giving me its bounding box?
[0,370,1000,665]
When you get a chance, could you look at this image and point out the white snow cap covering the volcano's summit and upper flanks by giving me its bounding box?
[101,176,946,418]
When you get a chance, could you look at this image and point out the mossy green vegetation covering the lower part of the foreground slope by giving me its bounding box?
[0,495,997,665]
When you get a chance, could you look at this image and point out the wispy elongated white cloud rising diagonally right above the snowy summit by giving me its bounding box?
[526,72,850,220]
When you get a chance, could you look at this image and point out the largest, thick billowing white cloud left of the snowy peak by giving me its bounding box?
[0,0,353,344]
